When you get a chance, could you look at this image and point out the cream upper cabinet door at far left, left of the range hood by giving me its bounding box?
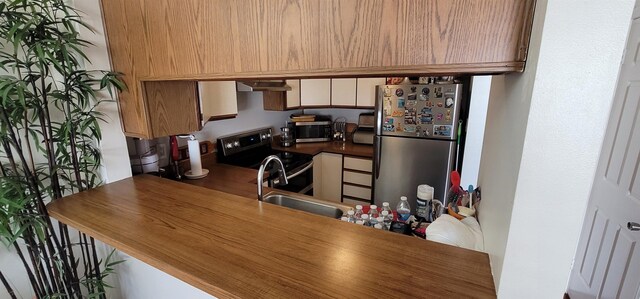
[198,81,238,122]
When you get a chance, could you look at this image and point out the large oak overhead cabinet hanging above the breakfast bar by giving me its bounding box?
[101,0,535,137]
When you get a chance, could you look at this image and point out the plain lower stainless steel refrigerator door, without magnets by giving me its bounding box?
[373,136,456,212]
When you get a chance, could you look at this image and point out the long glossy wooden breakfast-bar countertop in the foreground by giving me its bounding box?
[48,175,496,298]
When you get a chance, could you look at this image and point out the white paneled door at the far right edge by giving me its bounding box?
[567,5,640,299]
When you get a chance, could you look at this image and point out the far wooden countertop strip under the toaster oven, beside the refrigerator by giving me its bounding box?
[271,136,373,158]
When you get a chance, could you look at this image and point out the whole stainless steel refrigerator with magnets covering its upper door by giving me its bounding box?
[373,84,462,213]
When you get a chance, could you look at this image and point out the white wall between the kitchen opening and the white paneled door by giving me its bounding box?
[480,0,633,298]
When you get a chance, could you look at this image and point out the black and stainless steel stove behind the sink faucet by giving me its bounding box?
[216,128,313,195]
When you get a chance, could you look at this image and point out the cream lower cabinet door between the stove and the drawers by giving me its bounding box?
[313,153,342,202]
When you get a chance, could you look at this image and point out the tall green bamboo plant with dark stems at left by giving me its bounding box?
[0,0,123,298]
